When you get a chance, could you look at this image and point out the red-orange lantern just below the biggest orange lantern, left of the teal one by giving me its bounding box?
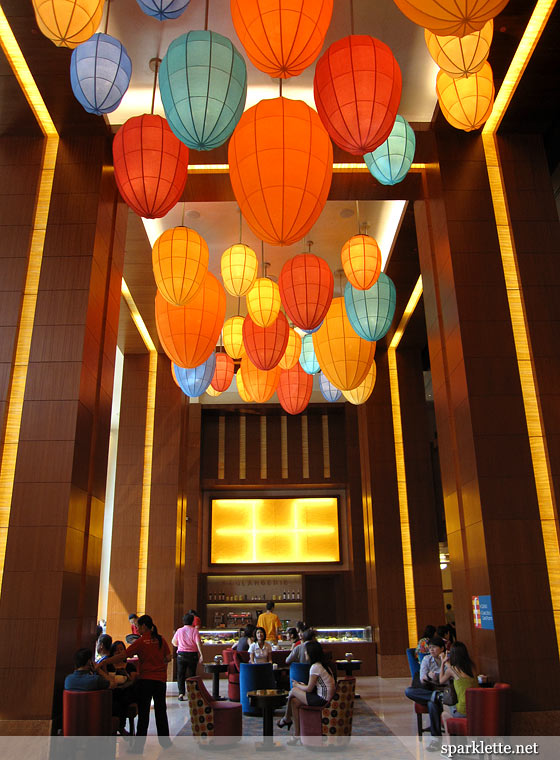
[278,253,334,330]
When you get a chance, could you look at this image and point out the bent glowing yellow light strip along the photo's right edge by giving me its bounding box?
[482,0,560,651]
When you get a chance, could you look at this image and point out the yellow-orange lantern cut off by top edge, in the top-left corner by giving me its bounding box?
[33,0,105,48]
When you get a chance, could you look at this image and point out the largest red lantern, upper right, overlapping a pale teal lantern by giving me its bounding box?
[313,34,402,156]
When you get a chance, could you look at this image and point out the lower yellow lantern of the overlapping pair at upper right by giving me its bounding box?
[436,62,494,132]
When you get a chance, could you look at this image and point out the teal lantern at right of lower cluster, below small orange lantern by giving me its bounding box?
[344,272,397,341]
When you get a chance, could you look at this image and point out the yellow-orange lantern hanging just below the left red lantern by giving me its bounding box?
[152,227,208,306]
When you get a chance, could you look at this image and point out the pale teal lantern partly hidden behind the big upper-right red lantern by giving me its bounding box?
[364,114,416,185]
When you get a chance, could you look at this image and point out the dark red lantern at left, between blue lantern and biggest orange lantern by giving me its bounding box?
[113,114,189,219]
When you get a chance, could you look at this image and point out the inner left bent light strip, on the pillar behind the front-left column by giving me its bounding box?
[121,277,158,613]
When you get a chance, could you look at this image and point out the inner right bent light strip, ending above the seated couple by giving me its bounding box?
[387,275,422,647]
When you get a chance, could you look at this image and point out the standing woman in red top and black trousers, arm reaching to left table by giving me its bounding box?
[104,615,172,755]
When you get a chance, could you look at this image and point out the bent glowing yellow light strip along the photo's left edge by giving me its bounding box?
[0,7,59,593]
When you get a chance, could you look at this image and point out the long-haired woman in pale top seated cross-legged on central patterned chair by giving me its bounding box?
[277,641,336,745]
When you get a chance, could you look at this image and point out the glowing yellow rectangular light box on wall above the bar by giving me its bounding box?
[210,497,340,564]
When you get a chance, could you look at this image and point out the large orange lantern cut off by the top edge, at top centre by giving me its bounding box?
[231,0,333,79]
